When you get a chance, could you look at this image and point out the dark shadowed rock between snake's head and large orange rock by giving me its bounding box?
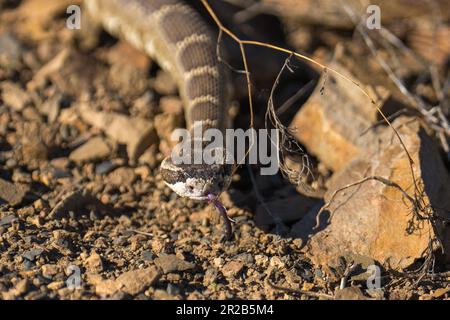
[255,195,319,226]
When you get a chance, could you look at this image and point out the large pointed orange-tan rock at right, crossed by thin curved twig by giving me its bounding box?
[303,117,450,269]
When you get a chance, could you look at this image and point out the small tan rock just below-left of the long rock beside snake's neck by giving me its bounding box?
[69,137,111,163]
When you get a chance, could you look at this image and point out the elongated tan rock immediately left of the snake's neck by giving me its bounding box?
[76,105,157,161]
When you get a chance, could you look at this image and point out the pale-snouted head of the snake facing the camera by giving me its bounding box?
[160,150,233,200]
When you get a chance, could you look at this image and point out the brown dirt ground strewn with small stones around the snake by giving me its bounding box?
[0,0,450,300]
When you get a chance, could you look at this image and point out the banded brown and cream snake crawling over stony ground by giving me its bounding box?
[85,0,231,200]
